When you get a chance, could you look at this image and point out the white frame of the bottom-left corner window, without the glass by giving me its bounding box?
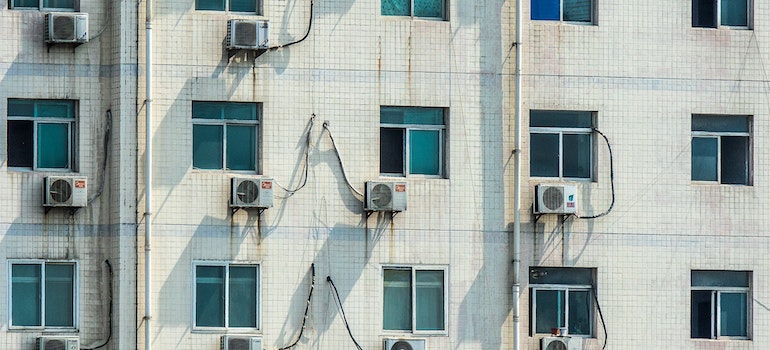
[7,259,80,332]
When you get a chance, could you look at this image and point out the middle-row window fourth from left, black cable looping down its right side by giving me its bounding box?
[529,110,594,179]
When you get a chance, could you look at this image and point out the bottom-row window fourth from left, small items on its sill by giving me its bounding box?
[529,267,596,337]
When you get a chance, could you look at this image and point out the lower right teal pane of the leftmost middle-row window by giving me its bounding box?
[37,123,70,169]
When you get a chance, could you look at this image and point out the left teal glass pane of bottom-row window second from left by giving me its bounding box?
[195,266,225,327]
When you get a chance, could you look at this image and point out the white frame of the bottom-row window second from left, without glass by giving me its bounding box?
[191,260,262,333]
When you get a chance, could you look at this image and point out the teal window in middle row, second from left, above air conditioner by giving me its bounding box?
[192,102,260,171]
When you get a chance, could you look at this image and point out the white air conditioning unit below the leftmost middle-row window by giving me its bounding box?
[43,176,88,207]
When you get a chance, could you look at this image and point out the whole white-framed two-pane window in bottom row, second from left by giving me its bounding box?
[194,263,259,329]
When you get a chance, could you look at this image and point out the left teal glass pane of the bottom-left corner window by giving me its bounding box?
[11,264,43,326]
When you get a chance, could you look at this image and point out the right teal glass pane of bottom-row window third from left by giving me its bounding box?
[414,271,444,331]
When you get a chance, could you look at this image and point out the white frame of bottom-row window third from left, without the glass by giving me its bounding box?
[380,265,449,336]
